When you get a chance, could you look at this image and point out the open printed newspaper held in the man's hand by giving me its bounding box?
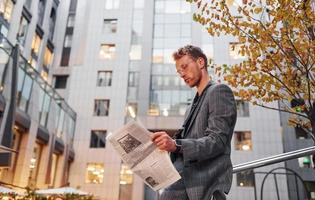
[107,121,181,191]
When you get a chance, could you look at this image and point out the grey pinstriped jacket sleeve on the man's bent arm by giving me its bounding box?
[181,84,236,164]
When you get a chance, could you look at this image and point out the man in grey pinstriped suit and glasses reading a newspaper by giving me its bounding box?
[152,45,236,200]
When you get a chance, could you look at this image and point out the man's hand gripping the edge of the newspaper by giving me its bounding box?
[152,131,176,152]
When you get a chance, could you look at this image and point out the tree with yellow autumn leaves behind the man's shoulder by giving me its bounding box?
[186,0,315,142]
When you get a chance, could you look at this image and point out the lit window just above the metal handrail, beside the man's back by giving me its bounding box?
[234,131,252,151]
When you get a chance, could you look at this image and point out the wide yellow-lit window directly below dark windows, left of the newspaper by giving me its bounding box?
[85,163,104,184]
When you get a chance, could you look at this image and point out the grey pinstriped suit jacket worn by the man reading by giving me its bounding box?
[171,82,236,200]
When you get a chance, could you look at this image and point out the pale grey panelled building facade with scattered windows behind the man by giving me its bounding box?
[51,0,287,199]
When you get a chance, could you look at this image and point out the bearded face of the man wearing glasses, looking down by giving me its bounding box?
[176,55,203,87]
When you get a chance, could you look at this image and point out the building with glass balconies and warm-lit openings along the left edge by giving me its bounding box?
[0,0,76,191]
